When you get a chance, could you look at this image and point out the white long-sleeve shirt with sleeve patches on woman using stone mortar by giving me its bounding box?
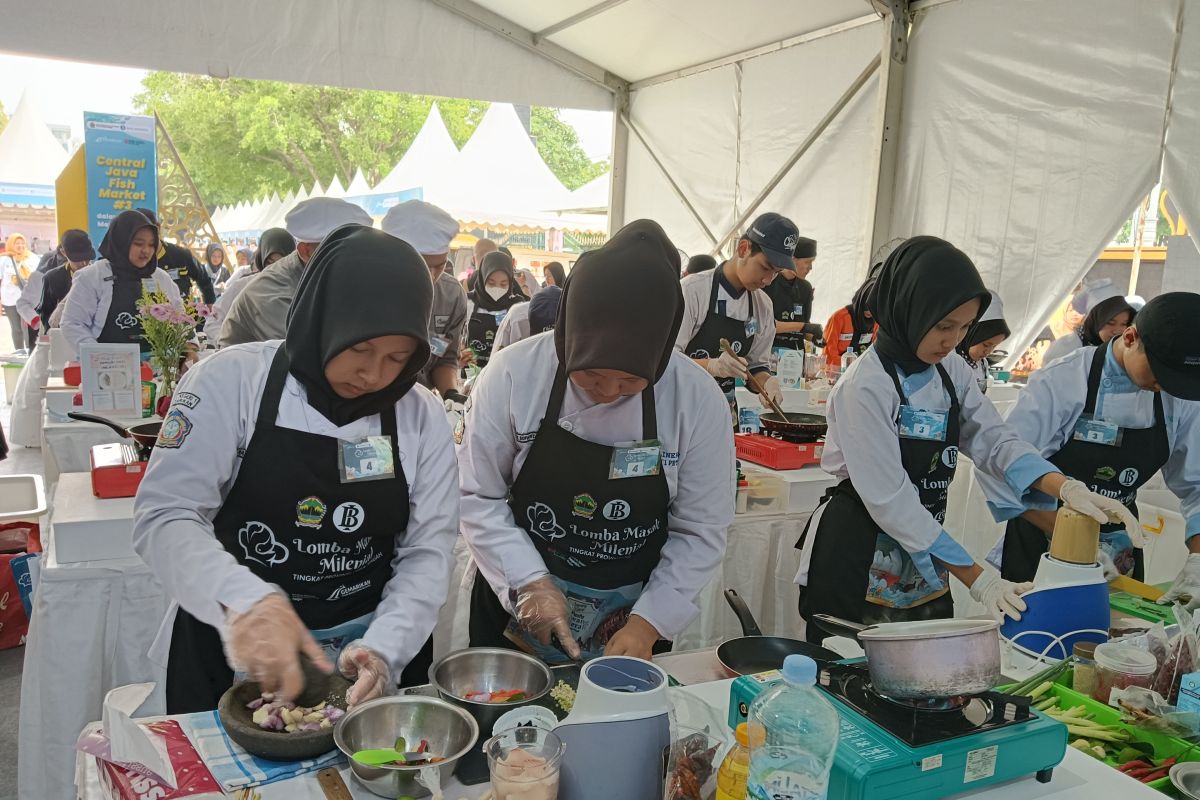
[133,341,458,675]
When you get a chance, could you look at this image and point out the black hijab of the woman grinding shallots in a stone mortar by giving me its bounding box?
[287,224,433,426]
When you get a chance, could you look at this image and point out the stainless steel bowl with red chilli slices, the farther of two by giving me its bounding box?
[430,648,554,739]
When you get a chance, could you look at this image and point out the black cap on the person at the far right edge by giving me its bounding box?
[1133,291,1200,401]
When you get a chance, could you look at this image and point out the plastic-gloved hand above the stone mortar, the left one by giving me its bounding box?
[222,594,334,700]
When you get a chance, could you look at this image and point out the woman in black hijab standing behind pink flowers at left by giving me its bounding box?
[62,211,181,357]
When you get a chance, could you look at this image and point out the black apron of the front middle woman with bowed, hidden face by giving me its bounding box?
[470,367,671,662]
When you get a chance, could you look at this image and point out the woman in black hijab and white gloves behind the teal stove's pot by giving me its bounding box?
[797,236,1123,642]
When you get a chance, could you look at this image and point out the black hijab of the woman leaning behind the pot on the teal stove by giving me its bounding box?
[866,236,991,375]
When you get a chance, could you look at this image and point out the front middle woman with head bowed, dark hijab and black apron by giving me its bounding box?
[458,221,733,663]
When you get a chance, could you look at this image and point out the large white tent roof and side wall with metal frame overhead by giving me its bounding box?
[0,0,1200,353]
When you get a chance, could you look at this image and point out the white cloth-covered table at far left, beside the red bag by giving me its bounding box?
[17,474,167,800]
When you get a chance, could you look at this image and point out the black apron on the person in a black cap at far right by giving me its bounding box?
[1000,344,1171,582]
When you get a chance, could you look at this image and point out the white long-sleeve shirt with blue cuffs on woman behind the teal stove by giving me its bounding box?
[797,348,1060,585]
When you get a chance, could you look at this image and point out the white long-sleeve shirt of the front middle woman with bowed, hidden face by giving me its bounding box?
[458,333,734,638]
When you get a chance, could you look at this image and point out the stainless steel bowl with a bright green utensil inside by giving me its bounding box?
[334,694,479,798]
